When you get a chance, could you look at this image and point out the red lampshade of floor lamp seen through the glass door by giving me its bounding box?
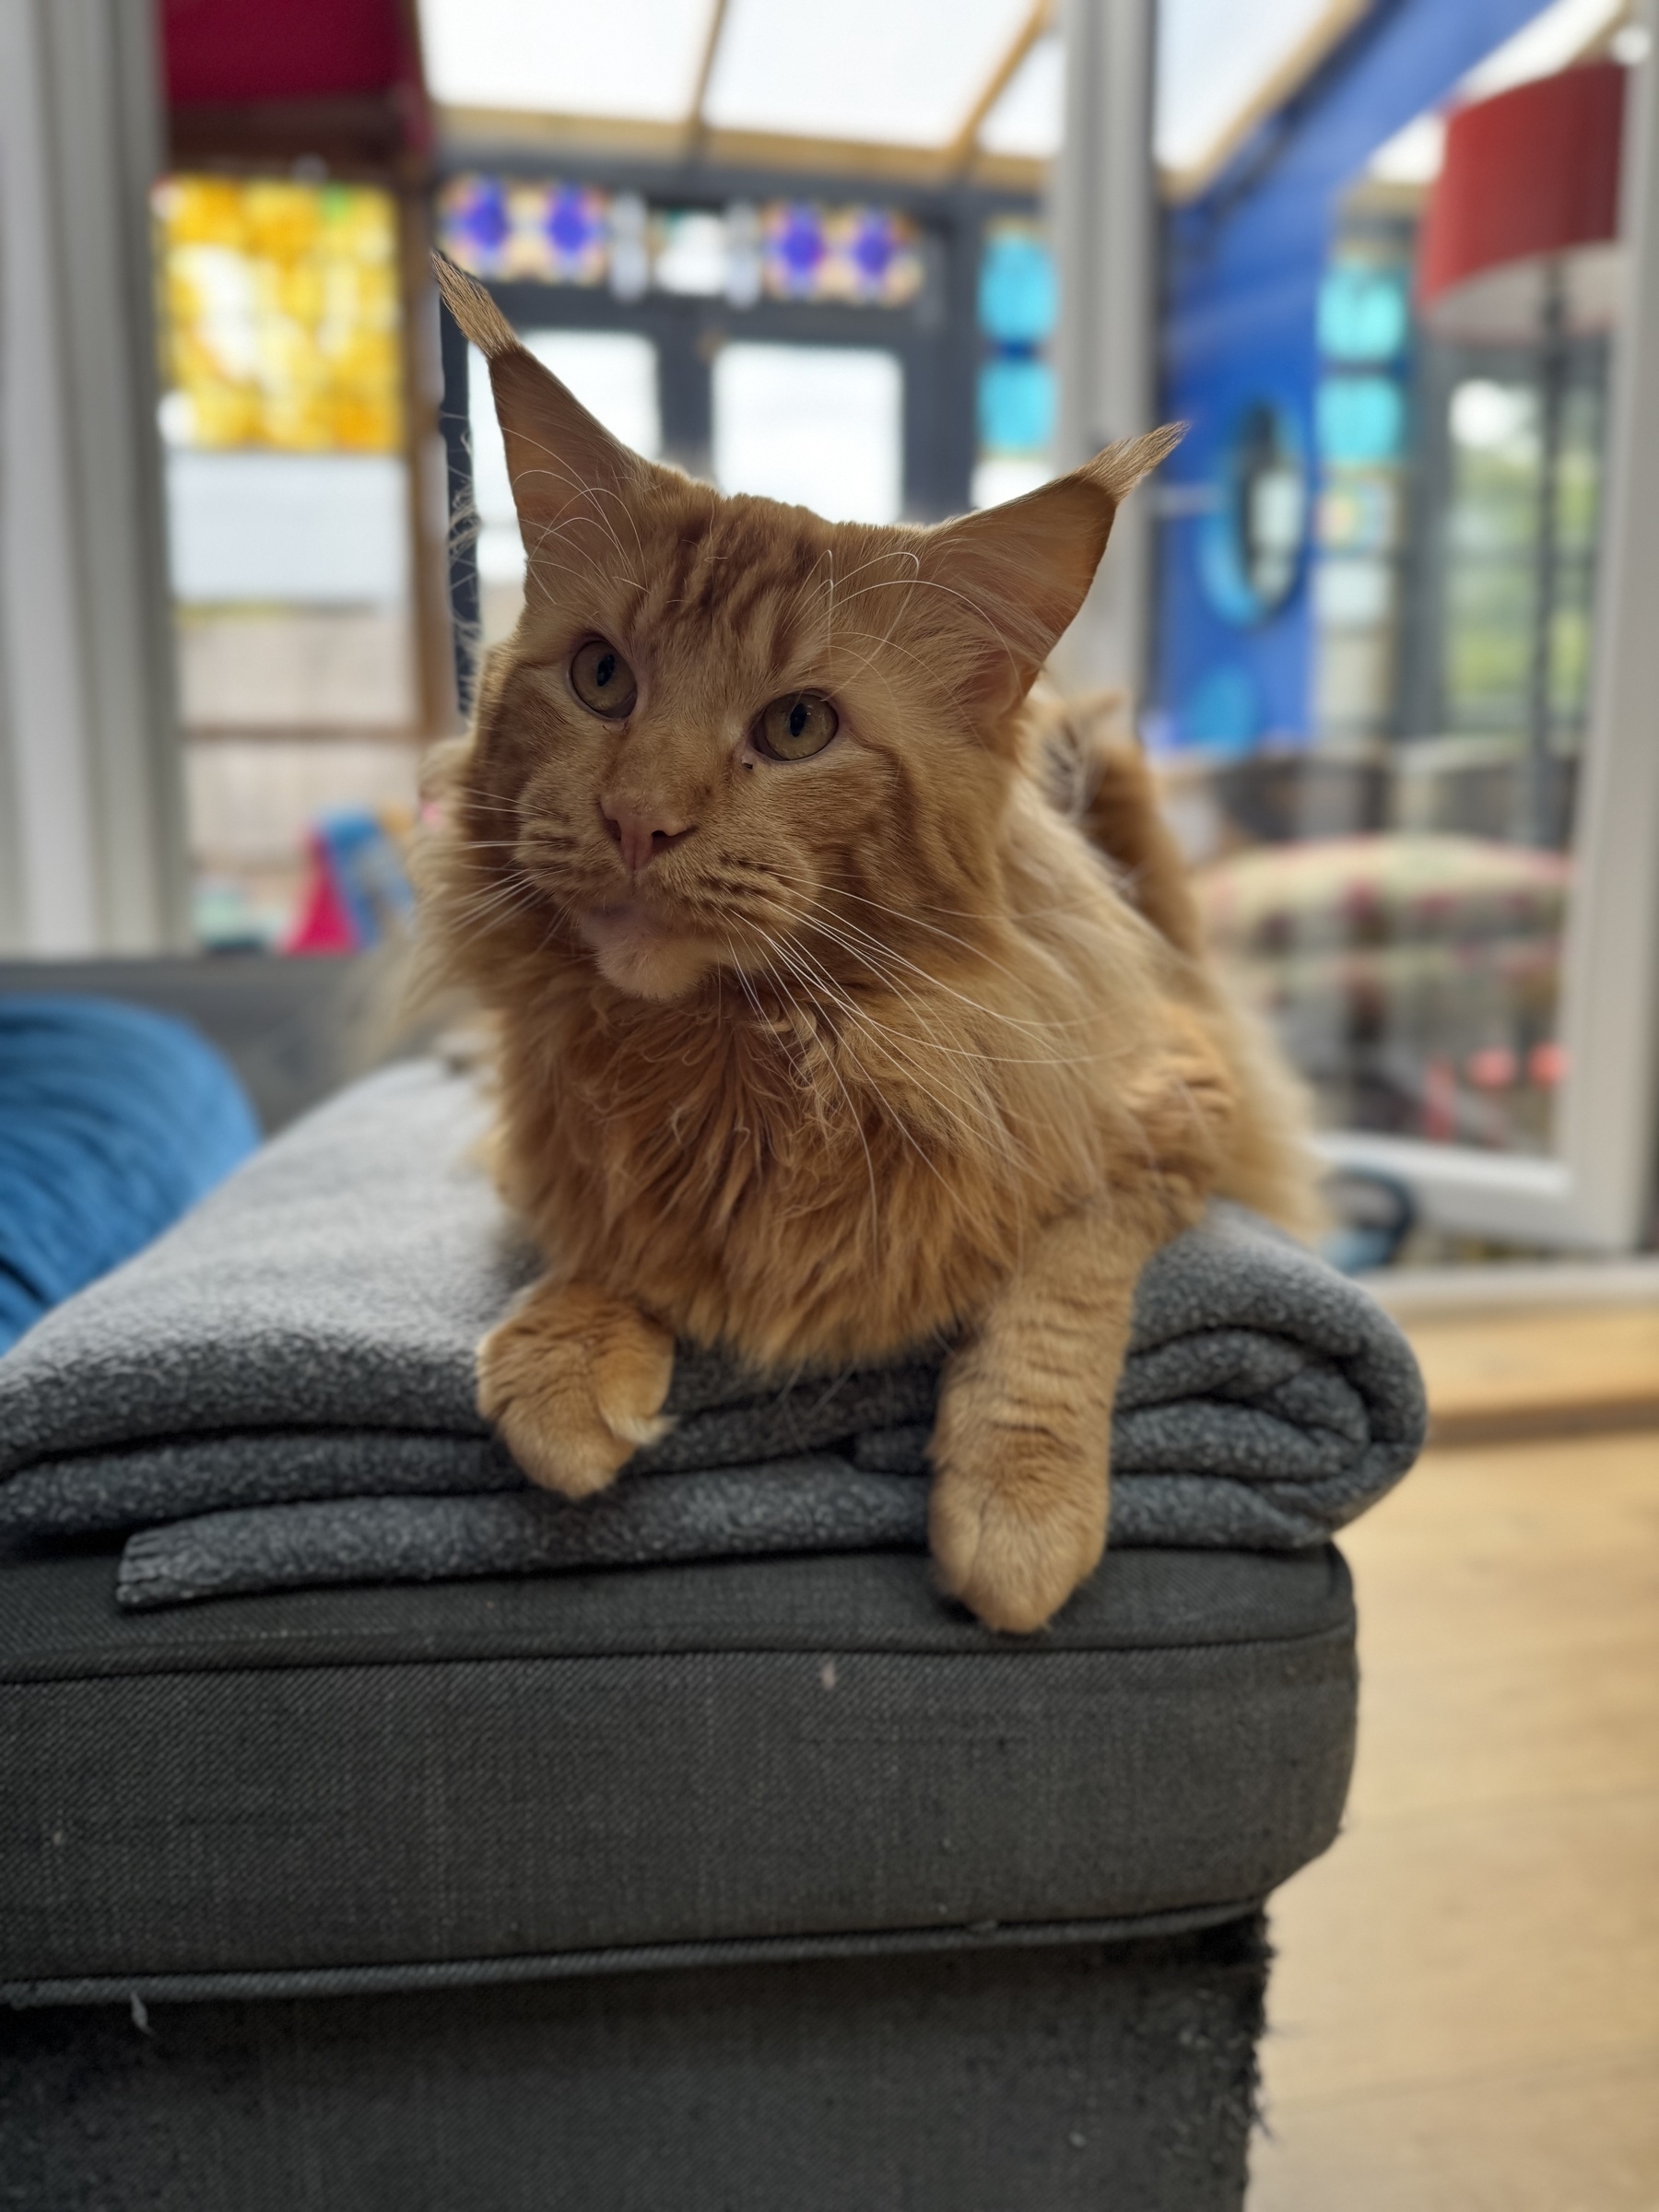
[1418,62,1624,308]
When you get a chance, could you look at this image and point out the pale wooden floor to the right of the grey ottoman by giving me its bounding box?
[1250,1424,1659,2212]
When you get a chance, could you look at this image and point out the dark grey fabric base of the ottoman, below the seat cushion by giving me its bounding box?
[0,1920,1265,2212]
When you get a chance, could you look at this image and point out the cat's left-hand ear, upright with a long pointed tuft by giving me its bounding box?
[431,254,651,539]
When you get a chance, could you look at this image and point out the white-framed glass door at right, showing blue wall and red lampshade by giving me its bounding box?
[1148,0,1659,1245]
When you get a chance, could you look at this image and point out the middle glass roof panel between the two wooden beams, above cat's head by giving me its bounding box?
[703,0,1030,146]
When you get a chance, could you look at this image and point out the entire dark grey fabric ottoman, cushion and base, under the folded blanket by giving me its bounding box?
[0,1548,1356,2212]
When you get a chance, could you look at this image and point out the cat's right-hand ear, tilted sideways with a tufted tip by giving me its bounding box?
[920,435,1185,714]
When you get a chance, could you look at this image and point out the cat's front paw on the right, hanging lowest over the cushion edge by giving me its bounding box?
[927,1418,1106,1635]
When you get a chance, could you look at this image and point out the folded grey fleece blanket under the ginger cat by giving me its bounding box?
[0,1062,1425,1606]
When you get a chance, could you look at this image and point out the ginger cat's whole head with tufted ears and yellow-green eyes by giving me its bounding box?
[438,264,1174,1000]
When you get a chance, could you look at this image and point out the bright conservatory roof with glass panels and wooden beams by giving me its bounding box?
[420,0,1371,188]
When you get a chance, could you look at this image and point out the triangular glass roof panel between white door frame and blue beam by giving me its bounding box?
[1155,0,1354,171]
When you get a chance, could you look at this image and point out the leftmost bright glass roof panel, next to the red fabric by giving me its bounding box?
[420,0,714,124]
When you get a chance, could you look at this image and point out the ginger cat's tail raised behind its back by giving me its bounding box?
[1033,690,1204,960]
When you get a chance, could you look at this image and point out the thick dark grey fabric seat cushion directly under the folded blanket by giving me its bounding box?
[0,1548,1354,1993]
